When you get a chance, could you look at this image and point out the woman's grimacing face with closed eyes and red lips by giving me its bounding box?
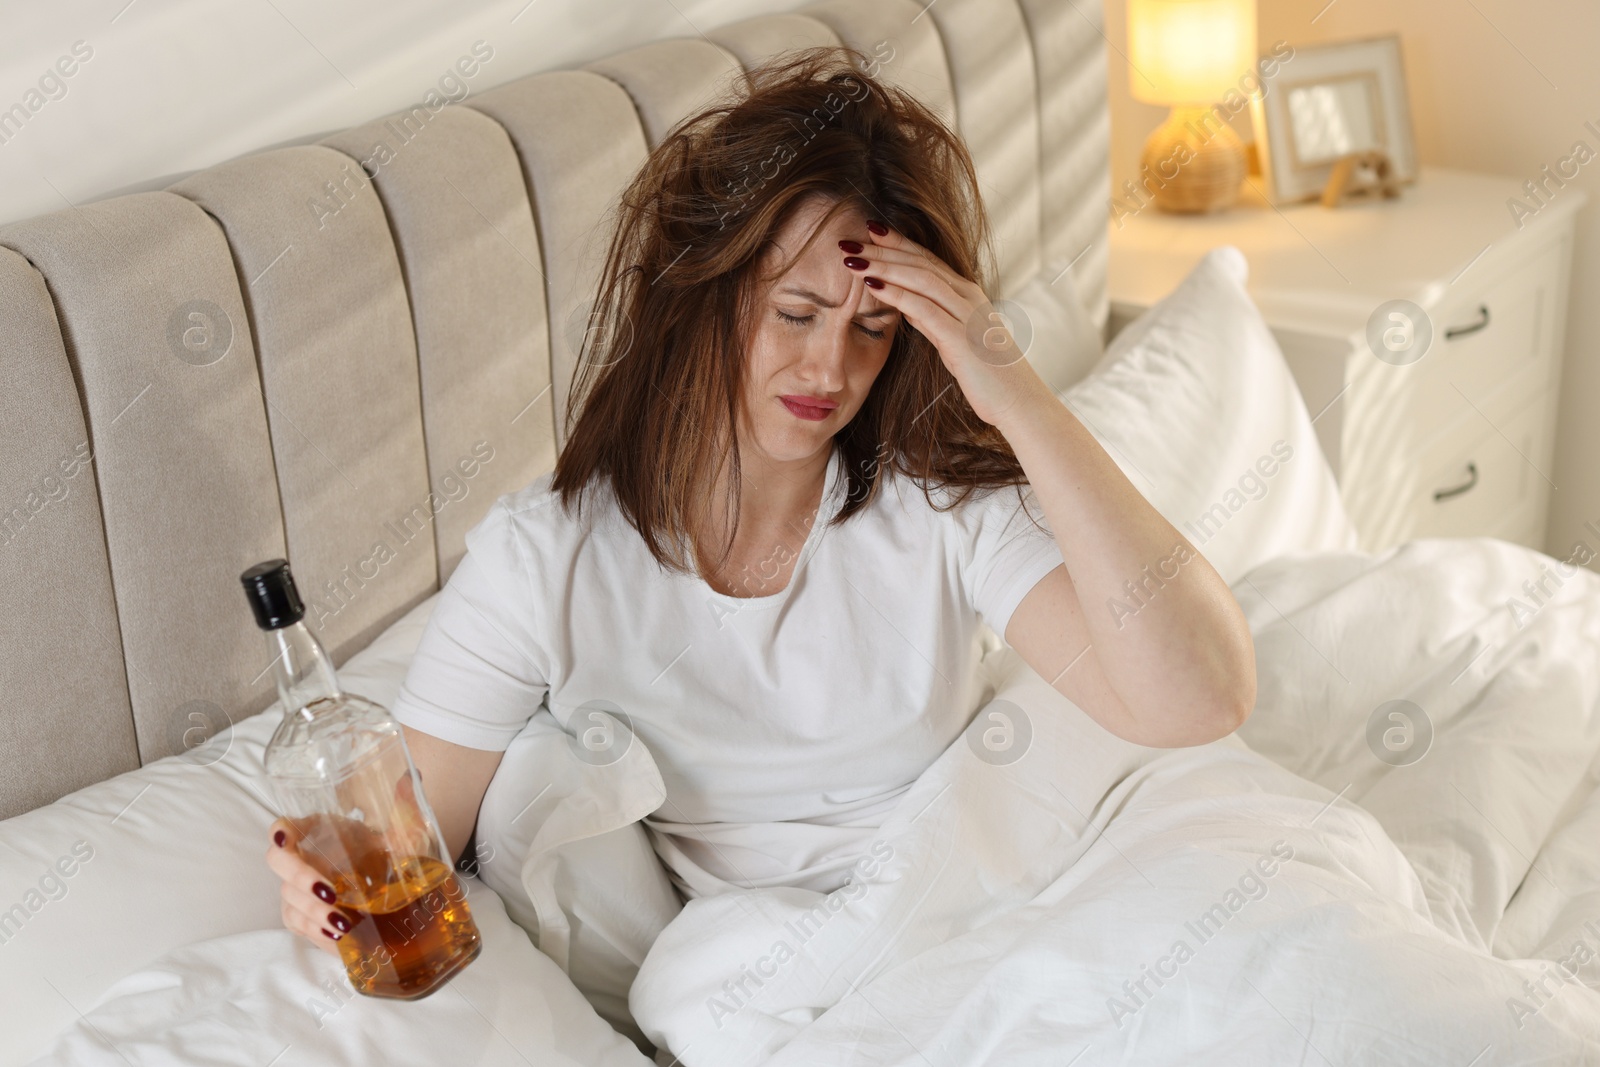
[739,198,899,462]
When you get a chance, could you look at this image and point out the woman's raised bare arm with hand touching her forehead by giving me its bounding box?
[840,222,1256,747]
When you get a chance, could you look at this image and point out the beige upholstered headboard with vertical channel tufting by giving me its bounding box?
[0,0,1109,816]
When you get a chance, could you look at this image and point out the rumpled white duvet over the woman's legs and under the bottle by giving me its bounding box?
[31,539,1600,1067]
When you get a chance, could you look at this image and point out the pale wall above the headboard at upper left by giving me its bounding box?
[0,0,798,222]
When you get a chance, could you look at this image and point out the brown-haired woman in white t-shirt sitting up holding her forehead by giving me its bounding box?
[267,50,1254,952]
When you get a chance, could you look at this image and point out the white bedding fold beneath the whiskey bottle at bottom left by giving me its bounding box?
[34,878,648,1067]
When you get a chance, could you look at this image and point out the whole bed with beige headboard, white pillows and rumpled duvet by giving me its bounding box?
[0,0,1600,1067]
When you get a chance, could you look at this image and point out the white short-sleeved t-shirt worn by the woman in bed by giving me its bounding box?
[394,454,1061,897]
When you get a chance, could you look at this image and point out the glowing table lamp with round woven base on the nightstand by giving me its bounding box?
[1128,0,1256,211]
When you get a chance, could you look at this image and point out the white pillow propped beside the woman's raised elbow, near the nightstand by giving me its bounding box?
[1058,246,1357,585]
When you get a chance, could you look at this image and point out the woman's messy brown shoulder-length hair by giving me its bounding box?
[552,46,1026,571]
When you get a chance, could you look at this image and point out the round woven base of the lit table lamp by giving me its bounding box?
[1141,107,1246,214]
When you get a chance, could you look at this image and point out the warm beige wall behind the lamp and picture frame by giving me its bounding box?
[1100,0,1600,558]
